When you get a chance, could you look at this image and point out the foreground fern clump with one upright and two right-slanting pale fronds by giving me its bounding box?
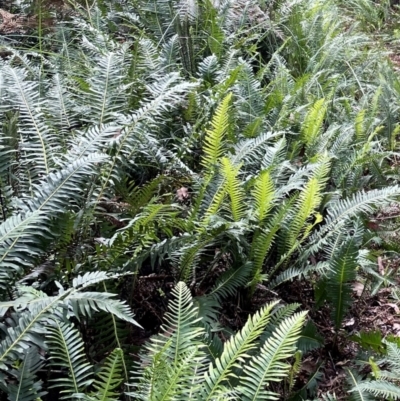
[128,282,306,400]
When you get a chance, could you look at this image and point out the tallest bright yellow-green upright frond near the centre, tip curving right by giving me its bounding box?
[201,93,232,171]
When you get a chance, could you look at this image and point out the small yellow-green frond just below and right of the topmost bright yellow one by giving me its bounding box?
[221,157,245,221]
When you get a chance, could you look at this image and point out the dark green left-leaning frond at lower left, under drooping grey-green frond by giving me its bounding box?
[46,320,93,399]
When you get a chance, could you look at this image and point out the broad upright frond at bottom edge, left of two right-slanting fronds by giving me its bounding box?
[128,282,206,401]
